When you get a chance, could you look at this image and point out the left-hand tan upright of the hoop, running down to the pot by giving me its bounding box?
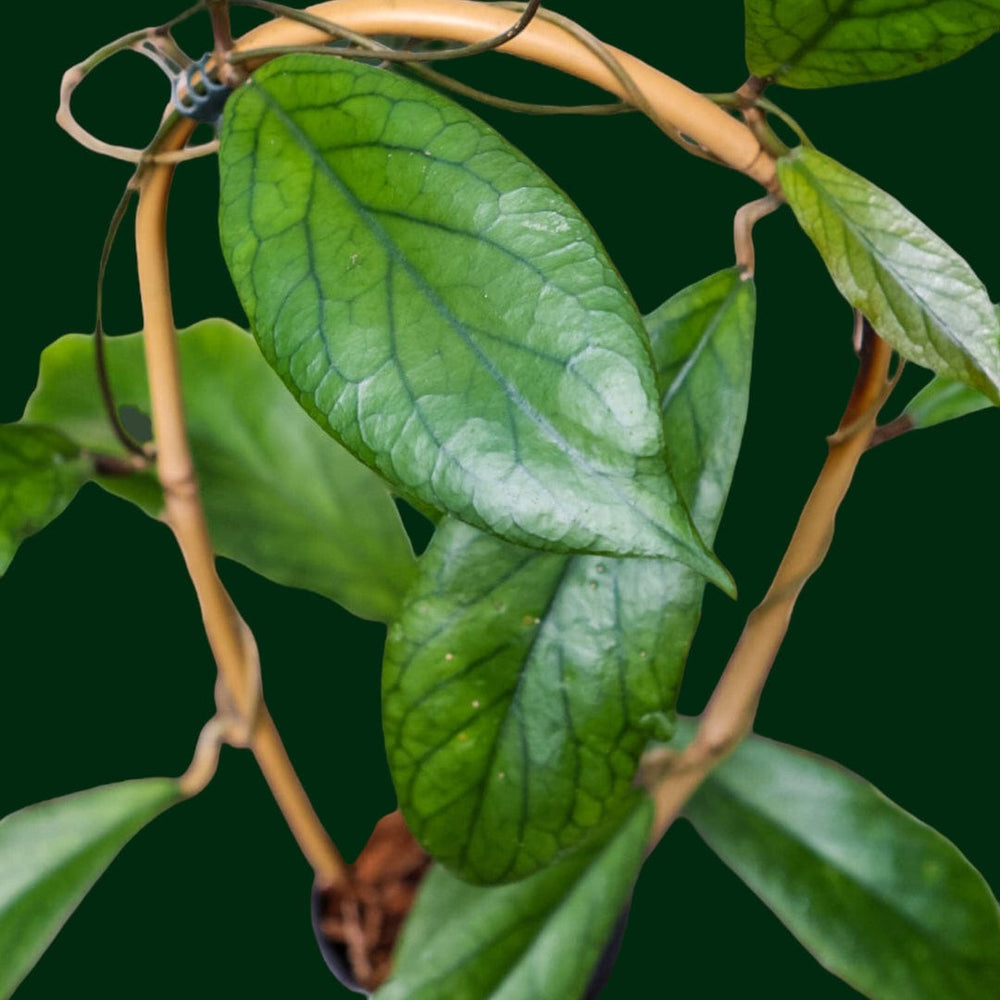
[136,120,348,888]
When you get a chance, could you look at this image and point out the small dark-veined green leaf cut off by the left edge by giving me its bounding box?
[0,424,91,574]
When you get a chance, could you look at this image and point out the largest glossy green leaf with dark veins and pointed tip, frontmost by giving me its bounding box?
[219,54,730,588]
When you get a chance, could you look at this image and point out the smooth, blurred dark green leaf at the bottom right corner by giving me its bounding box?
[682,723,1000,1000]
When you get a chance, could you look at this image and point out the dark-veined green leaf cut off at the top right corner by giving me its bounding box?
[745,0,1000,87]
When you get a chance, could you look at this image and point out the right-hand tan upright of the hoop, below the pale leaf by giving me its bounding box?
[644,324,892,849]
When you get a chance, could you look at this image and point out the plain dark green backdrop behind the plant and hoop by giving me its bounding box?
[0,0,1000,1000]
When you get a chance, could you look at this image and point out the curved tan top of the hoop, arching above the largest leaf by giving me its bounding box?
[233,0,778,191]
